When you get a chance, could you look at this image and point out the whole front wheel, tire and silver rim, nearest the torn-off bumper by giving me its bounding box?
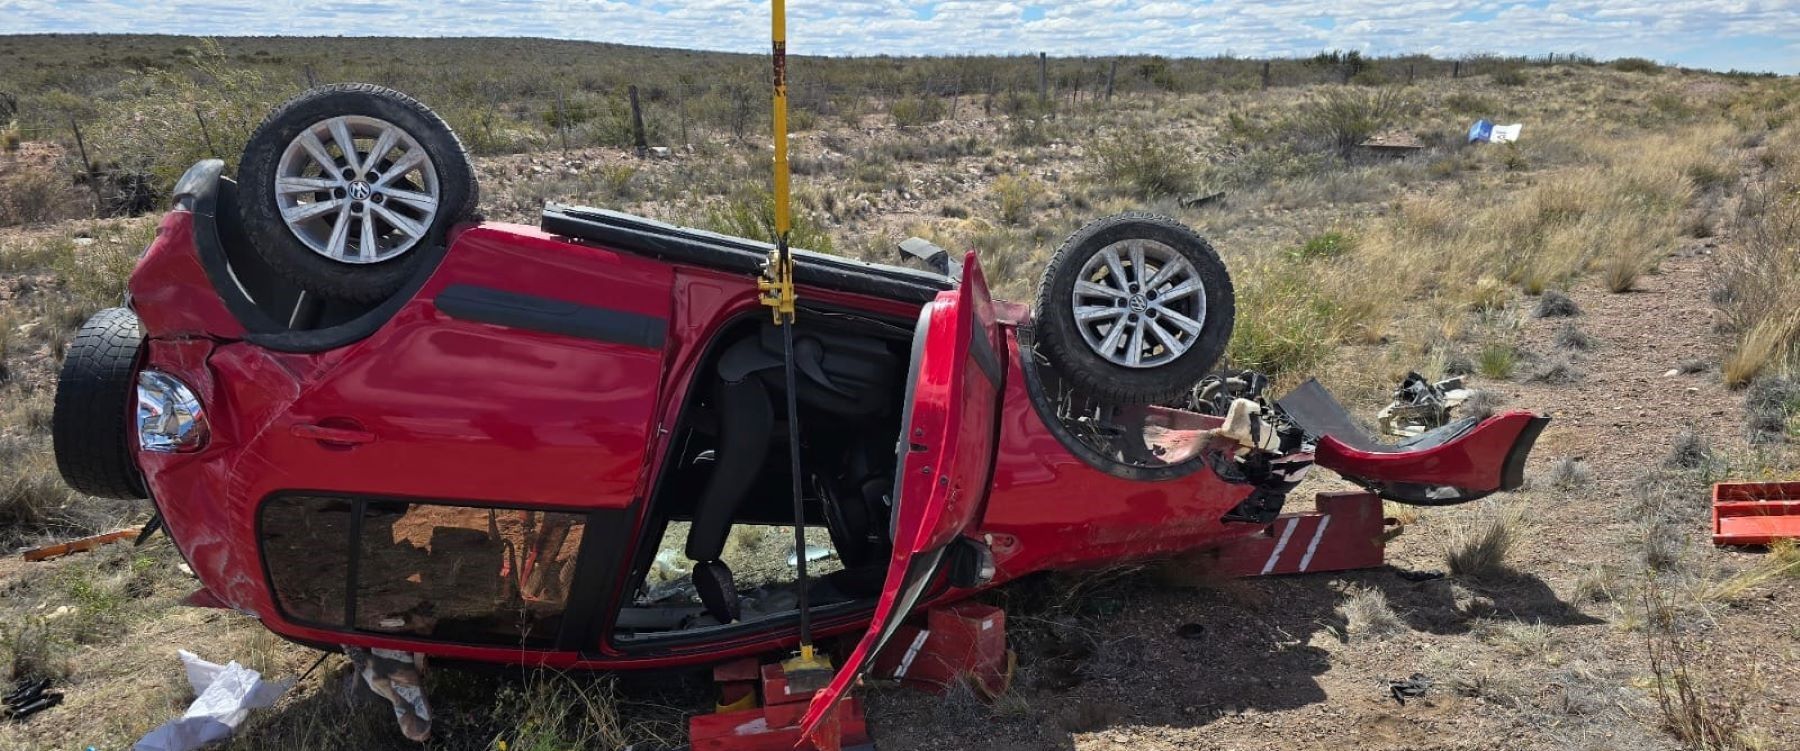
[1035,213,1237,403]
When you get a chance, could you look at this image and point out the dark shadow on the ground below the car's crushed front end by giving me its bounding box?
[871,567,1602,749]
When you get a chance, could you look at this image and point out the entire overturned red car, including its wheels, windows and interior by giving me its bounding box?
[54,86,1546,741]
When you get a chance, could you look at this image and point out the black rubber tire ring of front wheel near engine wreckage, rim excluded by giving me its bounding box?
[1033,211,1237,403]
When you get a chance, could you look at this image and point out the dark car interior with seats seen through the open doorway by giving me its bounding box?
[614,310,913,639]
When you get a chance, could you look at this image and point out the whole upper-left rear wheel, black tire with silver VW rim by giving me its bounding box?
[238,83,479,303]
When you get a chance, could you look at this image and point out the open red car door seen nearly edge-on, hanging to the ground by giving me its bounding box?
[803,252,1004,744]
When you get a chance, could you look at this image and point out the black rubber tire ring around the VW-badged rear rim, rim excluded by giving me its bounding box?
[238,83,481,303]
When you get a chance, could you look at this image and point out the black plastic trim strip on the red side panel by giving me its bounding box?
[434,285,668,349]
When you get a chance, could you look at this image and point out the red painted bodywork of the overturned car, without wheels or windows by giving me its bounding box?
[116,164,1541,723]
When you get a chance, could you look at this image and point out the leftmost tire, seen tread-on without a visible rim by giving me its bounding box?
[50,308,149,499]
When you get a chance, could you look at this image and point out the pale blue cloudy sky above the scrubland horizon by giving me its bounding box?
[0,0,1800,74]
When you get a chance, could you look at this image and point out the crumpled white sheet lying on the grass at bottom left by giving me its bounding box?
[131,650,293,751]
